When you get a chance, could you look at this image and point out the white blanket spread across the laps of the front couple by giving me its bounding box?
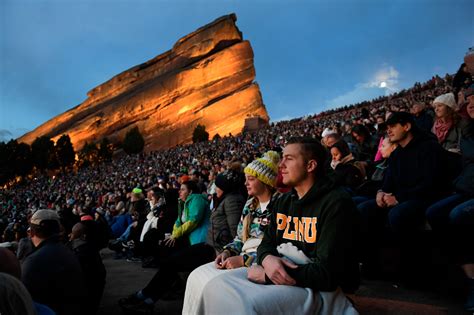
[183,262,358,315]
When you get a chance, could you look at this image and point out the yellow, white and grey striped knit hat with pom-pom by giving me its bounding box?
[244,151,280,187]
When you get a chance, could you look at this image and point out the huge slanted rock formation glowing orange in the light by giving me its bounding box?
[19,14,269,151]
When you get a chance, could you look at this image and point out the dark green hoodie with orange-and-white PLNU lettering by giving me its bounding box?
[257,178,360,291]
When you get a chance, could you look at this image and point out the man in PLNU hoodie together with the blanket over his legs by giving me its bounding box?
[193,138,359,314]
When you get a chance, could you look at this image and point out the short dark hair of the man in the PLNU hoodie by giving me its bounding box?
[286,137,328,177]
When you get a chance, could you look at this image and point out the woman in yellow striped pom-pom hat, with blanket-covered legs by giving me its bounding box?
[183,151,280,314]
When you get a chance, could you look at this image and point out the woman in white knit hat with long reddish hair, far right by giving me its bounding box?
[431,93,467,153]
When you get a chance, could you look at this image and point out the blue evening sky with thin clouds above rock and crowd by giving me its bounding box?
[0,0,474,141]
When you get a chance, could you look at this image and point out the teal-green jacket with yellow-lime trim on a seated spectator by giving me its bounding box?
[172,194,210,245]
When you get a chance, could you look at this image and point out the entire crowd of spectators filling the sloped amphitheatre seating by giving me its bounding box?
[0,50,474,314]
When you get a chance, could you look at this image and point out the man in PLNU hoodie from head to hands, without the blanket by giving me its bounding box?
[248,138,359,291]
